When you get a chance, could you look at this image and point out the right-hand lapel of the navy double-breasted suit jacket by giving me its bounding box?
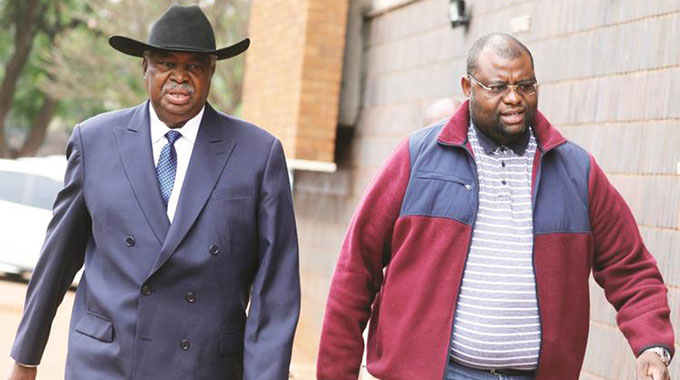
[151,104,236,273]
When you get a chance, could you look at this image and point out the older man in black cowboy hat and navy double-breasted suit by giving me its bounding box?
[11,5,300,380]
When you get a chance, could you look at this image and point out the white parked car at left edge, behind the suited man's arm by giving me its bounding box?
[0,156,80,284]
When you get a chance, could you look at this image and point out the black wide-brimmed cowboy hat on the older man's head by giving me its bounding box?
[109,4,250,60]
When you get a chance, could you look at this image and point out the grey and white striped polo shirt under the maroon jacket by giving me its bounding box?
[450,124,541,370]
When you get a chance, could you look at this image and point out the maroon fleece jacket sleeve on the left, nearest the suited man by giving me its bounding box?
[317,140,410,380]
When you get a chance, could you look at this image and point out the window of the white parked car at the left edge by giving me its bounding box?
[0,171,62,210]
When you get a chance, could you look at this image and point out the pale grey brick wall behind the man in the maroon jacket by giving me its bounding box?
[294,0,680,380]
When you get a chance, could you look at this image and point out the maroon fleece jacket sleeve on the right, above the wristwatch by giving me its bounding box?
[588,156,674,356]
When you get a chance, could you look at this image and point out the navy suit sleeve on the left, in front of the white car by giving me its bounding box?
[11,127,91,365]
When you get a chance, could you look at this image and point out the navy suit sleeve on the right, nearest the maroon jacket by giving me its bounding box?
[244,140,300,380]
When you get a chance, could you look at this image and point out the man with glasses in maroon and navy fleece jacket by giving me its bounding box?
[317,33,674,380]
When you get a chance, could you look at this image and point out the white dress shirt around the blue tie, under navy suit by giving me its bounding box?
[149,103,205,223]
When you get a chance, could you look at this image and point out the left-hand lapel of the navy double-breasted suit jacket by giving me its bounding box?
[113,101,170,244]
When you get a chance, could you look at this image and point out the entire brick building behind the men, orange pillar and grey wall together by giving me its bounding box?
[243,0,680,380]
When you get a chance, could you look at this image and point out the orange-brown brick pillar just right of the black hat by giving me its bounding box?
[243,0,349,162]
